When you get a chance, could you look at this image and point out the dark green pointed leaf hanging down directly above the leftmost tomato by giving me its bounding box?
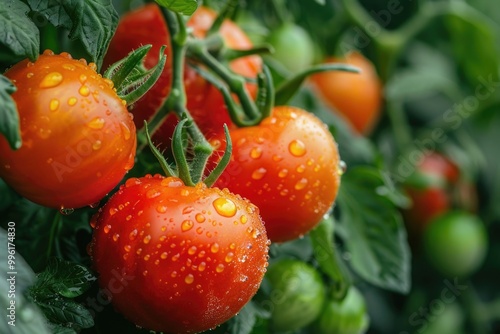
[28,0,118,68]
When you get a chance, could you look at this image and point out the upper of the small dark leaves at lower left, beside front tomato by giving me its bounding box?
[32,258,96,298]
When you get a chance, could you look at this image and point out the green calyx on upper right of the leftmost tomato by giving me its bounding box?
[104,45,167,105]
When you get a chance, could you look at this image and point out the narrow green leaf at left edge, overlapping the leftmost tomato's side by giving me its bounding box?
[0,75,22,150]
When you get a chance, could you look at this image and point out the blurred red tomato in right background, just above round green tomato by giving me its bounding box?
[404,152,475,236]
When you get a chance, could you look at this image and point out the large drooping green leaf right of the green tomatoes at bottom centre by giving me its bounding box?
[337,166,411,293]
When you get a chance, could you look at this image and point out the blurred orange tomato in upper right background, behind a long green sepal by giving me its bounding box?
[311,52,383,135]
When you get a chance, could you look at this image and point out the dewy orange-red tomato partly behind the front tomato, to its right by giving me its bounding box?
[215,106,340,242]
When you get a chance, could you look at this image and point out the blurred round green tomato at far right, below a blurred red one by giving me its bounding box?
[423,211,488,277]
